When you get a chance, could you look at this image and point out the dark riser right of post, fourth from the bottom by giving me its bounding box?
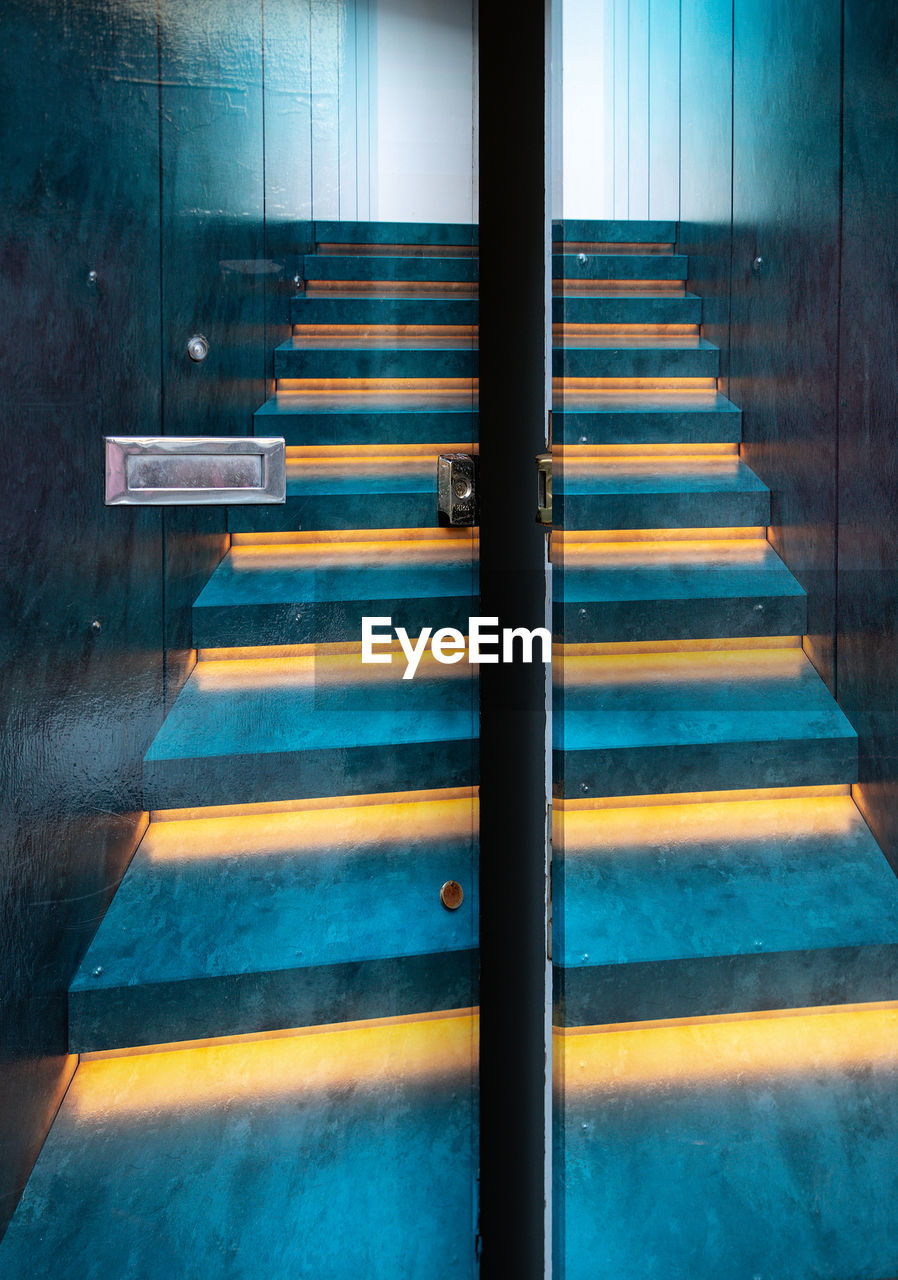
[553,492,770,531]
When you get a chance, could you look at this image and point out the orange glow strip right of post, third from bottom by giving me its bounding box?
[560,636,807,692]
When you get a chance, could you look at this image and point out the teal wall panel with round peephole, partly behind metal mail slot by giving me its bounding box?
[159,0,266,696]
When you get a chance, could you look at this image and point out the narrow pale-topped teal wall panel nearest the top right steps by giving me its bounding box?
[678,0,733,376]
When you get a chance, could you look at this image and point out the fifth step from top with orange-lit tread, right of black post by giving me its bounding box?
[553,389,742,444]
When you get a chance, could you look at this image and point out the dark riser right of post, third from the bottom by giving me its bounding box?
[553,595,807,644]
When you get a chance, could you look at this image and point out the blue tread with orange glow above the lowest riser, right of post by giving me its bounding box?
[554,796,898,967]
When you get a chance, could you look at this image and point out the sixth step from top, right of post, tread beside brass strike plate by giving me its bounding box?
[553,454,770,530]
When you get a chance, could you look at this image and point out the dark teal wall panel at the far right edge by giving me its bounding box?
[837,0,898,867]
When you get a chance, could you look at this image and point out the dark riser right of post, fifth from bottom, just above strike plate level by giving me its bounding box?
[553,410,742,444]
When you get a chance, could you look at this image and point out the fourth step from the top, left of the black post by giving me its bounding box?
[274,334,477,379]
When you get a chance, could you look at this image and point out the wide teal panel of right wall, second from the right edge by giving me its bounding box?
[729,0,840,686]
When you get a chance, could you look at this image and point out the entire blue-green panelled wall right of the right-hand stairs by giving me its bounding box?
[681,0,898,867]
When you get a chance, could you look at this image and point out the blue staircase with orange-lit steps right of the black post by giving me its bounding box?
[551,221,898,1280]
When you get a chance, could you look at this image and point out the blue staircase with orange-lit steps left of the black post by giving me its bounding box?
[0,223,486,1280]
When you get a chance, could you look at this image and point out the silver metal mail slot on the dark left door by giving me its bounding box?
[106,435,287,507]
